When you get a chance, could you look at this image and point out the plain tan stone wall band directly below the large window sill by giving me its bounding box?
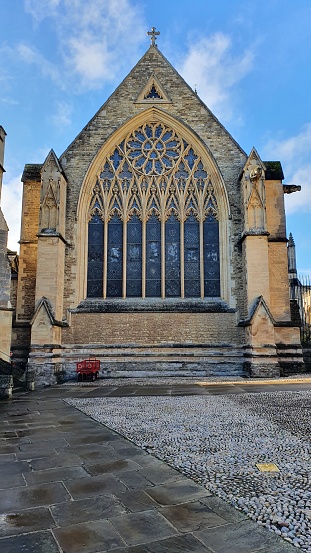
[62,313,243,345]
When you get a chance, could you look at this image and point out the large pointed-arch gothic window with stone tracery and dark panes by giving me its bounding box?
[87,123,220,298]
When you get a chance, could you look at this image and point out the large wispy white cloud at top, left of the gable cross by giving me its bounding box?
[20,0,146,90]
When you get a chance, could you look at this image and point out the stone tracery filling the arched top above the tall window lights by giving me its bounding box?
[89,122,218,222]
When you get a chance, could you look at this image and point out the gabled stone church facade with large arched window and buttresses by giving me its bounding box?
[5,35,308,381]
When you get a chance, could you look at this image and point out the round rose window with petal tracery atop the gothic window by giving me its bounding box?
[125,124,182,175]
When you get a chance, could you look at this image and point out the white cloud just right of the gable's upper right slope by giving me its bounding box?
[179,33,253,120]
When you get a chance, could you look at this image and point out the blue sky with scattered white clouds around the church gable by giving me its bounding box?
[0,0,311,274]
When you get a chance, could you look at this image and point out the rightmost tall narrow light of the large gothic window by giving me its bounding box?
[203,215,220,297]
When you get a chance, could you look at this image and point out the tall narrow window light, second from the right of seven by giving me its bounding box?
[184,215,200,298]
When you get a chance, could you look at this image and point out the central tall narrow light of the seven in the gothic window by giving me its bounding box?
[146,215,161,298]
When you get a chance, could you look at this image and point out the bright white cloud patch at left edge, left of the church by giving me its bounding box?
[1,175,23,251]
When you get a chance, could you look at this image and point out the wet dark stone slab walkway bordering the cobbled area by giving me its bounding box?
[0,379,311,553]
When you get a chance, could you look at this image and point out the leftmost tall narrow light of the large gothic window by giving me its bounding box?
[87,213,104,298]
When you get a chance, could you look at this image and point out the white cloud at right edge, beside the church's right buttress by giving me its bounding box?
[264,123,311,214]
